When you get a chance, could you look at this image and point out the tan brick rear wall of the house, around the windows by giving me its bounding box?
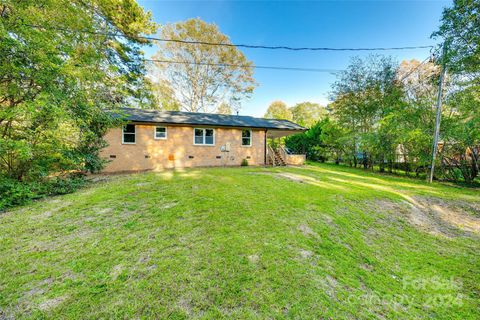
[101,124,265,172]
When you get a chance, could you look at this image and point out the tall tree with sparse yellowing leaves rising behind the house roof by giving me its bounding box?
[154,18,256,112]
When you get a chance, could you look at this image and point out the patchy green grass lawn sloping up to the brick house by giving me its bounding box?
[0,165,480,319]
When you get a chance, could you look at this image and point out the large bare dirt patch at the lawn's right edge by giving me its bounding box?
[375,196,480,238]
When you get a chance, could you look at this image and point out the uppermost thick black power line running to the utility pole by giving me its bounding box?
[23,24,434,51]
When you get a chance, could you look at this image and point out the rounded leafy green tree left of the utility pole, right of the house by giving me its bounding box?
[330,55,404,168]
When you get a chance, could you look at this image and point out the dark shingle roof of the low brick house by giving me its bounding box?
[114,108,306,131]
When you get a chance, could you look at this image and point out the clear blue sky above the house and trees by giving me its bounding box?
[139,0,450,116]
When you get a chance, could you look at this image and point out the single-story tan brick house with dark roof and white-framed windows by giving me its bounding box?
[101,108,306,172]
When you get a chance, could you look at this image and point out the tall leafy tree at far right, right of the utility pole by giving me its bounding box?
[432,0,480,182]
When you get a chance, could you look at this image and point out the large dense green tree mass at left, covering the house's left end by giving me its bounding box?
[0,0,156,185]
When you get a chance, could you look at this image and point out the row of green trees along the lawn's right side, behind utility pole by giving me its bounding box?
[286,1,480,182]
